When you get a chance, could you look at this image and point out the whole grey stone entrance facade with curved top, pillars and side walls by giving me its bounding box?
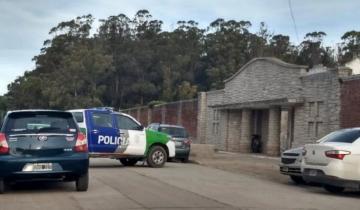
[200,58,352,155]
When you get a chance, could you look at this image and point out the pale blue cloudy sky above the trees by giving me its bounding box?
[0,0,360,95]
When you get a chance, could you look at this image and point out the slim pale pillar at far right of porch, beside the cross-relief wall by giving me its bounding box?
[280,107,289,152]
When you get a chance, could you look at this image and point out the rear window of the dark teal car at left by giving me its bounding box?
[5,112,77,134]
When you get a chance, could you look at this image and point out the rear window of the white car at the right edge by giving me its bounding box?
[319,130,360,143]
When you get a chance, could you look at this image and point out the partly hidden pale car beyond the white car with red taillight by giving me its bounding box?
[280,147,304,184]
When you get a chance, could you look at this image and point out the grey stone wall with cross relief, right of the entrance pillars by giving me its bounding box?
[292,69,340,147]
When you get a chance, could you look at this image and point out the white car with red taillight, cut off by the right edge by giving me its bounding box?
[301,128,360,193]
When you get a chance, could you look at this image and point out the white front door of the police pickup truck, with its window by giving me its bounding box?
[114,114,146,156]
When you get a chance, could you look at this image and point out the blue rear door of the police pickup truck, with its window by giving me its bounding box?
[86,110,120,153]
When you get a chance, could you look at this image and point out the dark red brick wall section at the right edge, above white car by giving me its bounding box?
[340,76,360,128]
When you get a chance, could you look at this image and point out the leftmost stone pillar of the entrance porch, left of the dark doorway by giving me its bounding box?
[239,109,251,152]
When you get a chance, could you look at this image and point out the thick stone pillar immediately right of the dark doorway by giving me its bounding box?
[265,107,280,156]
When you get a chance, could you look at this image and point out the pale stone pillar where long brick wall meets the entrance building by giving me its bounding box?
[196,92,210,144]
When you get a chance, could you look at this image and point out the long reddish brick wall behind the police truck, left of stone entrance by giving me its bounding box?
[121,99,198,139]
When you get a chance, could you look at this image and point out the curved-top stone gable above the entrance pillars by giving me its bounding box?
[223,58,305,104]
